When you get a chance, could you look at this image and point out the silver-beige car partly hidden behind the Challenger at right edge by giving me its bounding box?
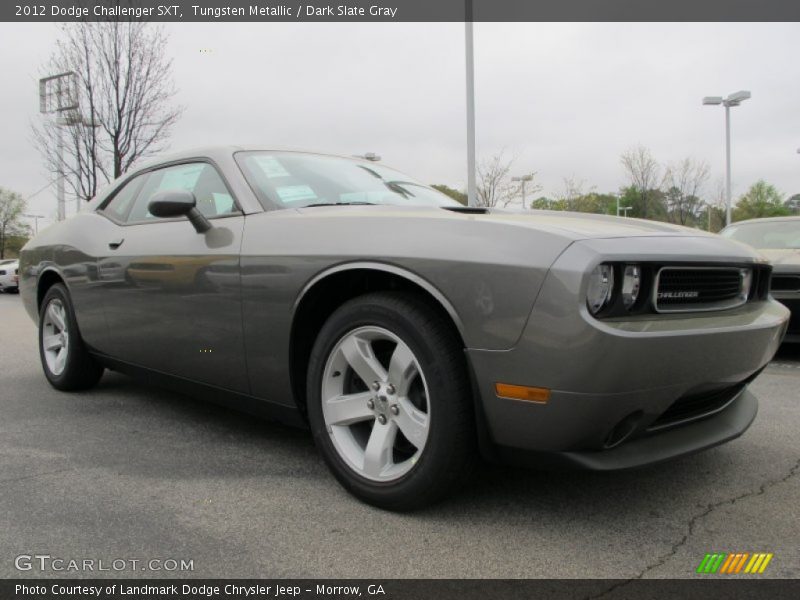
[720,217,800,343]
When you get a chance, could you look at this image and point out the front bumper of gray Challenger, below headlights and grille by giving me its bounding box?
[467,239,789,469]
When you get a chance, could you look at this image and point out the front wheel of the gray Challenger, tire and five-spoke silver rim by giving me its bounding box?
[306,292,476,511]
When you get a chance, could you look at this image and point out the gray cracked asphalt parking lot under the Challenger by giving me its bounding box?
[0,294,800,578]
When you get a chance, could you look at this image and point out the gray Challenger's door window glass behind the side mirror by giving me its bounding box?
[127,163,239,223]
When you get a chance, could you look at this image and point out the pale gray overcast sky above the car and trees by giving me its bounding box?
[0,23,800,226]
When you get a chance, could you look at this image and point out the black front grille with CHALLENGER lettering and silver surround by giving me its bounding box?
[653,267,752,312]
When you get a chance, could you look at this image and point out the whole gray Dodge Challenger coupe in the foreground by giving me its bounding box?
[19,148,788,510]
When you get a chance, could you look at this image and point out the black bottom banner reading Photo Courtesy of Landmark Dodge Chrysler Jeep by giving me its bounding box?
[0,577,800,600]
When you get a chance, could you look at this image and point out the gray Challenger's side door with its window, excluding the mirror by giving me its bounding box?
[98,161,248,392]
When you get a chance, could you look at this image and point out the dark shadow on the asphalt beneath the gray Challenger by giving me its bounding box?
[59,373,772,519]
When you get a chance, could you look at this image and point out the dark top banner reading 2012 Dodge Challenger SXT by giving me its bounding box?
[0,0,800,23]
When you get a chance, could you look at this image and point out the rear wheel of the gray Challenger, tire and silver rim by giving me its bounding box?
[39,283,103,391]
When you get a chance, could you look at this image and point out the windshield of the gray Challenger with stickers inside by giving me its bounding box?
[236,152,460,208]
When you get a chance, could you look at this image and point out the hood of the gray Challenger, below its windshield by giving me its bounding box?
[298,205,719,241]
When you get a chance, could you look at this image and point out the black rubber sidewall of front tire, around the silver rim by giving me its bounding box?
[307,295,469,509]
